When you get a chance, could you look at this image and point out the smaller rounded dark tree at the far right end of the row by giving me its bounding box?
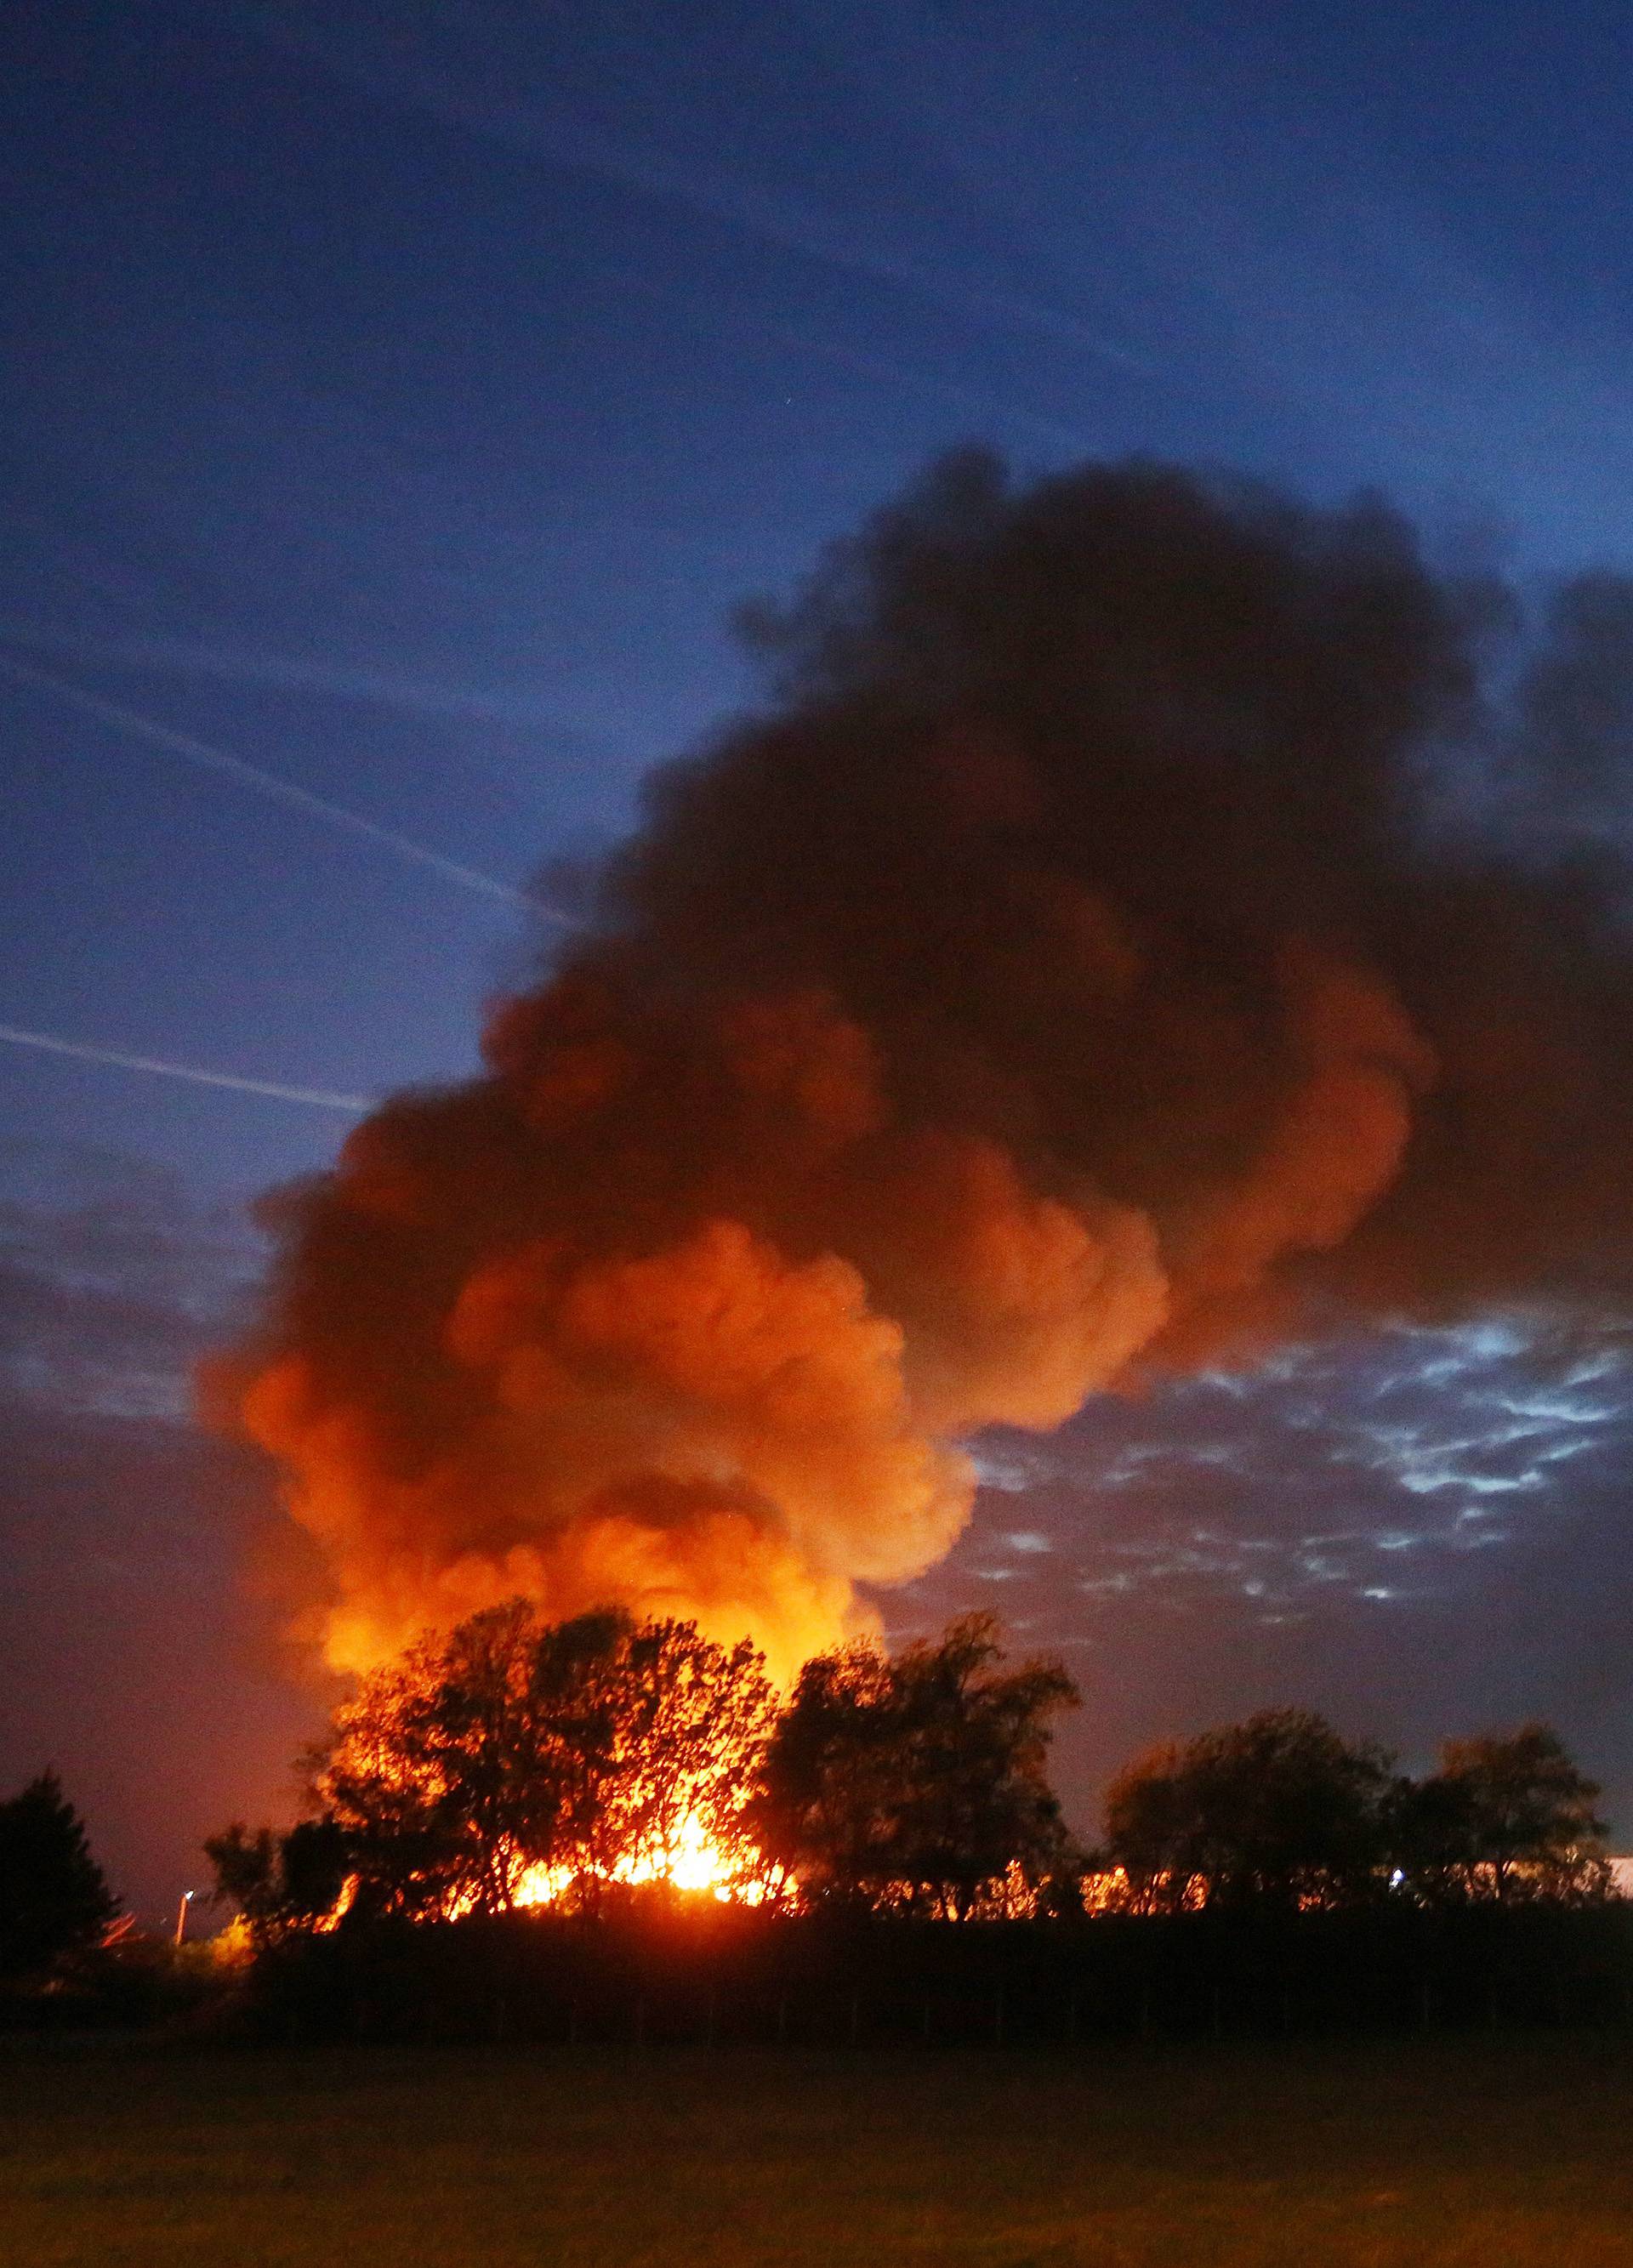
[1391,1724,1610,1903]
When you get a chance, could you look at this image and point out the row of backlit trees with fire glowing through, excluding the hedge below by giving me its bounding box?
[207,1601,1613,1937]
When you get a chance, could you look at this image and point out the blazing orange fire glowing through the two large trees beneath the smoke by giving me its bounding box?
[264,1599,1078,1930]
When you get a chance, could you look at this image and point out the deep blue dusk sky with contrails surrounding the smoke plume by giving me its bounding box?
[0,0,1633,1914]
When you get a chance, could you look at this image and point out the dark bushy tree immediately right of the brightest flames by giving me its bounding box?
[751,1615,1078,1917]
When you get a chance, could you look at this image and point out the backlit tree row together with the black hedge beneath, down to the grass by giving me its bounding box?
[195,1601,1633,2041]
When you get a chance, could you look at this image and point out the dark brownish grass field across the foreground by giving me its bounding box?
[0,2034,1633,2268]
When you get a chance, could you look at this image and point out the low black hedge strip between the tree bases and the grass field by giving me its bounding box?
[226,1896,1633,2053]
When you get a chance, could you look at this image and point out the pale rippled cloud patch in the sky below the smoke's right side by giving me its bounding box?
[939,1313,1633,1629]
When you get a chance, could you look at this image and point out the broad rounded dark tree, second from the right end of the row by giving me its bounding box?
[1107,1708,1392,1907]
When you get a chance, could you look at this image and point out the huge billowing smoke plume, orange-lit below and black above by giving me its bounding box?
[223,456,1633,1669]
